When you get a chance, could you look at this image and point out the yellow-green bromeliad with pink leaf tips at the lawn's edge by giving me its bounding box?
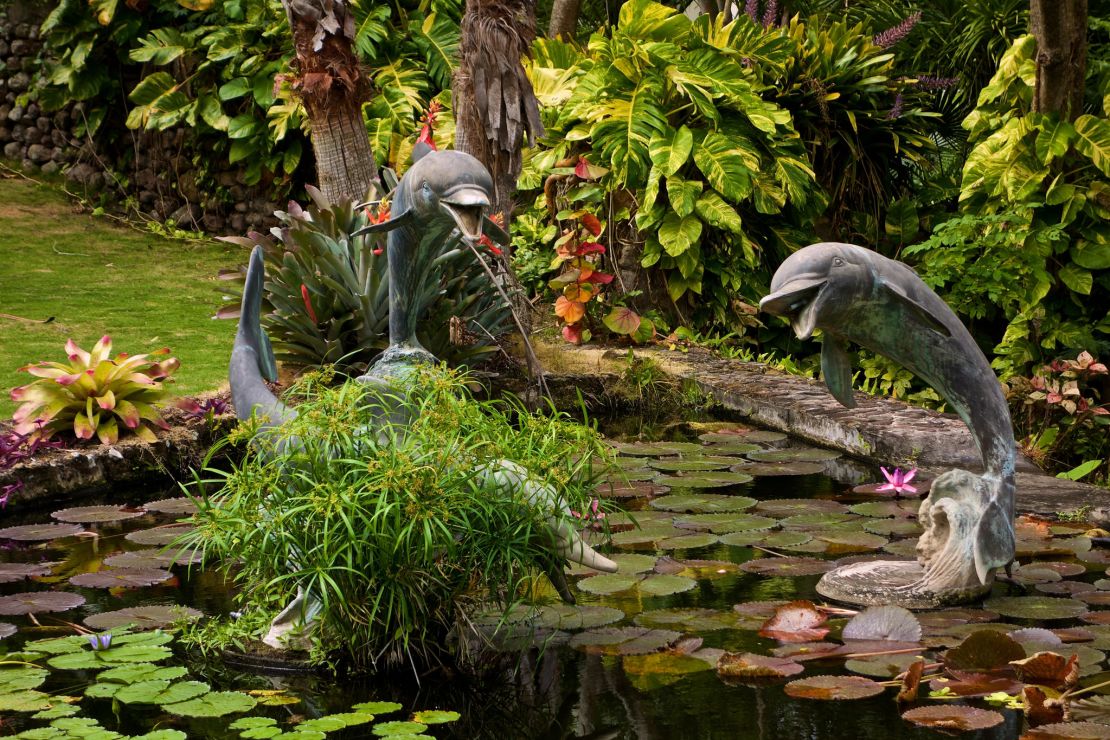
[11,334,181,445]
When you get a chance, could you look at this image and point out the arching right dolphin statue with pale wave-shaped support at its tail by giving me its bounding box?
[759,243,1016,607]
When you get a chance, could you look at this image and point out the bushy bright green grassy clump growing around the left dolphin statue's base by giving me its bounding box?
[185,368,612,668]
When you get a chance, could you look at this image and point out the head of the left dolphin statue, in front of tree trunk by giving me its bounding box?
[405,151,493,240]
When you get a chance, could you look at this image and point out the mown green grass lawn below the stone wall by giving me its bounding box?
[0,171,245,418]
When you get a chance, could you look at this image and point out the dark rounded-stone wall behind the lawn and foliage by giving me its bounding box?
[0,0,278,234]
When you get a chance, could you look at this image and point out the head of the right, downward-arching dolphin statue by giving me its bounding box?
[759,242,874,339]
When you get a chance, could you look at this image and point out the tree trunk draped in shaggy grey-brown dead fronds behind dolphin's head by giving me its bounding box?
[452,0,543,339]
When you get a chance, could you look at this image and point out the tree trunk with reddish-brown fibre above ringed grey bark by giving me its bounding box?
[282,0,379,202]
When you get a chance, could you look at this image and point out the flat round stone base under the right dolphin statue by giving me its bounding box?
[817,560,991,609]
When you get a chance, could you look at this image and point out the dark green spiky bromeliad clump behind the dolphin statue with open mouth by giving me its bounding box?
[218,186,509,374]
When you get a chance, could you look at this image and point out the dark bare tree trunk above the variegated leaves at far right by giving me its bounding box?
[1029,0,1087,120]
